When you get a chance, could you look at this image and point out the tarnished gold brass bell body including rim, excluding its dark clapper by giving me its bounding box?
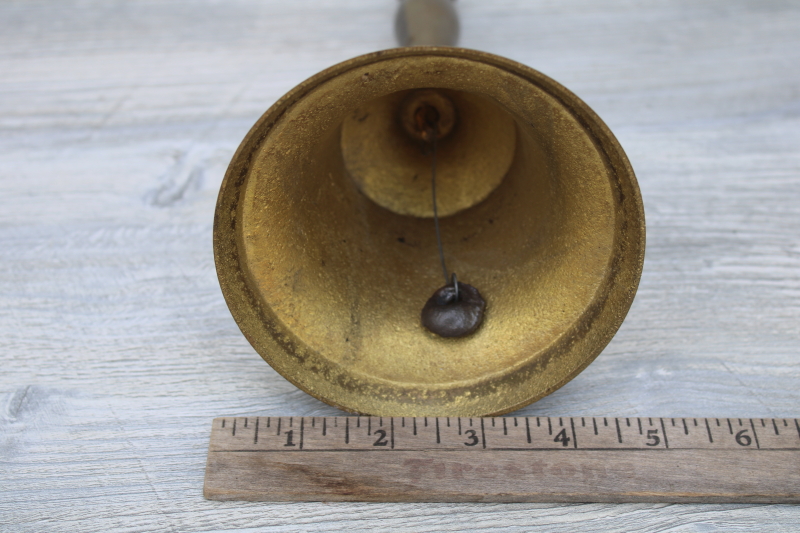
[214,47,645,416]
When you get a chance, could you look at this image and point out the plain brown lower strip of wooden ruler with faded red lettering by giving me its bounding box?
[205,450,800,503]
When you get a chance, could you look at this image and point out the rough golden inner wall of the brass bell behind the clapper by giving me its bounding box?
[231,51,638,415]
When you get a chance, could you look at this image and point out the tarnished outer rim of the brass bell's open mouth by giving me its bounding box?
[213,46,646,416]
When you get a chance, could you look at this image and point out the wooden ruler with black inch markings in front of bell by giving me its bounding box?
[204,417,800,503]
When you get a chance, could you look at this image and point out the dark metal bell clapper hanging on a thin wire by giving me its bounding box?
[413,103,486,337]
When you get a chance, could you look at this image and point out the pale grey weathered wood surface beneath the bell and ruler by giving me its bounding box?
[0,0,800,532]
